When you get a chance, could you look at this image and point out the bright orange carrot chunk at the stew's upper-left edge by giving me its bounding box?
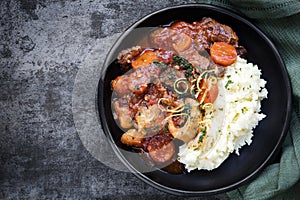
[131,49,158,69]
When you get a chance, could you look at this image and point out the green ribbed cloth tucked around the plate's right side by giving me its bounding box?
[198,0,300,200]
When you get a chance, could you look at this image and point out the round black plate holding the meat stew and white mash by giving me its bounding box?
[97,4,291,195]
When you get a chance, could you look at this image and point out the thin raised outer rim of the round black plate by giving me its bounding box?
[95,3,292,196]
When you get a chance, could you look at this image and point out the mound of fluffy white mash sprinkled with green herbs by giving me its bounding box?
[178,57,268,171]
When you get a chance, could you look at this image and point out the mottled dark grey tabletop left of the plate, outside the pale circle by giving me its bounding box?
[0,0,226,199]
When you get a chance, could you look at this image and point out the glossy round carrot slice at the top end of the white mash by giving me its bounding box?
[210,42,237,66]
